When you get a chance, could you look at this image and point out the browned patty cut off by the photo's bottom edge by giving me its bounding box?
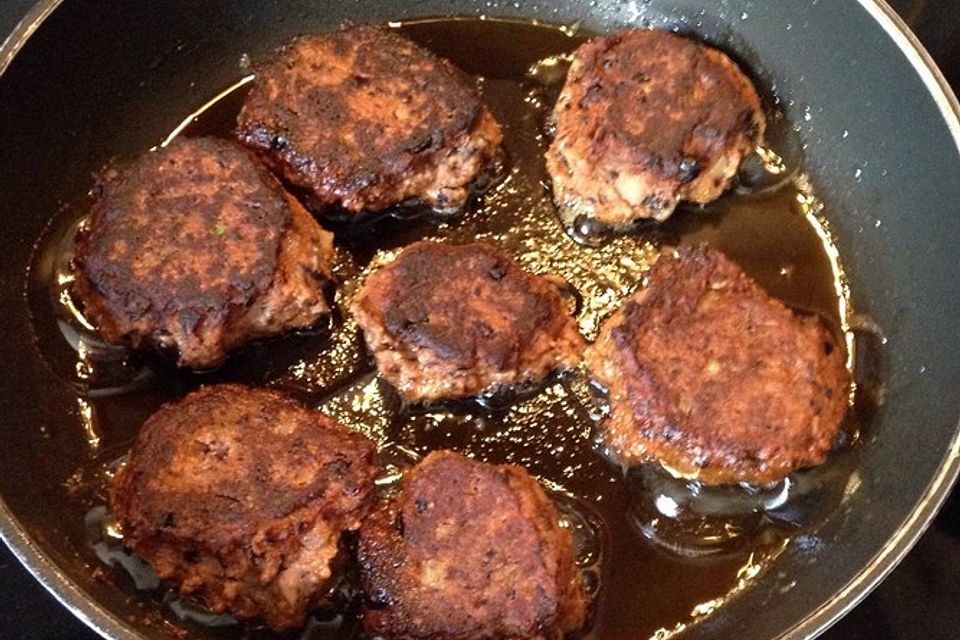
[359,451,585,640]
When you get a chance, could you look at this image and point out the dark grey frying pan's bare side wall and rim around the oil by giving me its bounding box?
[0,0,960,640]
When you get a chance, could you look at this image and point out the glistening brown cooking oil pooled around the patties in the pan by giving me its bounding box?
[28,13,867,639]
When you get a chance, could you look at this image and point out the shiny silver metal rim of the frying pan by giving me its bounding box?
[0,0,960,640]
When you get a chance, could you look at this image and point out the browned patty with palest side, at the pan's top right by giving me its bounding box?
[546,29,765,227]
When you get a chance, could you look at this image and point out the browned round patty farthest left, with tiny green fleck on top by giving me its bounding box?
[73,138,333,368]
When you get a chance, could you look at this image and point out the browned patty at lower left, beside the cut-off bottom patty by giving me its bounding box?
[111,385,376,629]
